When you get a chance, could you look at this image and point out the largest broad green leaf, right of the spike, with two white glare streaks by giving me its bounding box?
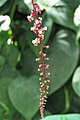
[48,29,79,93]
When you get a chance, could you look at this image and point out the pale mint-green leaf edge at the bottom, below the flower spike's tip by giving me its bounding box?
[42,114,80,120]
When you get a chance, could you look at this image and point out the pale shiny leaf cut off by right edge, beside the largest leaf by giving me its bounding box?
[72,66,80,97]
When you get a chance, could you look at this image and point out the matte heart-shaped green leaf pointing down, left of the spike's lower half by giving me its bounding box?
[9,76,39,120]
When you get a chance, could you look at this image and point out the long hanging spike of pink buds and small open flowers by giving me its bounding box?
[27,0,50,118]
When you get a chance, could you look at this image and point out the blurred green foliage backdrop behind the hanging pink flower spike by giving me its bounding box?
[0,0,80,120]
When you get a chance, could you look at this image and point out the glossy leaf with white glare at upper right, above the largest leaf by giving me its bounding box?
[46,5,75,29]
